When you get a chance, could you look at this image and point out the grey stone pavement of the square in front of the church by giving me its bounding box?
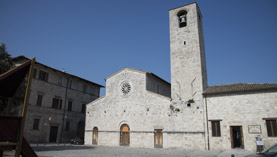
[29,144,254,157]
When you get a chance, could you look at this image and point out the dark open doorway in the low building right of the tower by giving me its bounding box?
[230,126,244,149]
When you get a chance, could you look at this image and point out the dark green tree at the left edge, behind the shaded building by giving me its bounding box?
[0,43,14,74]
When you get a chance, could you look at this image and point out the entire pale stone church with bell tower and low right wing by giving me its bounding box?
[85,3,277,151]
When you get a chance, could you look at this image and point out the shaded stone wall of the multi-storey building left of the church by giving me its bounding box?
[21,64,99,143]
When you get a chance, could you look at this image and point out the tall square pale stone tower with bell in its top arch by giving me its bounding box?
[169,3,207,103]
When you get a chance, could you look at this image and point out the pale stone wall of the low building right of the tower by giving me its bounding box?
[206,92,277,151]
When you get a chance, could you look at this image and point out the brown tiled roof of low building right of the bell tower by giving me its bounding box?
[203,83,277,95]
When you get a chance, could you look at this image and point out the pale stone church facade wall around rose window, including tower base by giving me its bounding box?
[85,68,205,149]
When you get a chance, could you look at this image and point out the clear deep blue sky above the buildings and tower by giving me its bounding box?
[0,0,277,95]
